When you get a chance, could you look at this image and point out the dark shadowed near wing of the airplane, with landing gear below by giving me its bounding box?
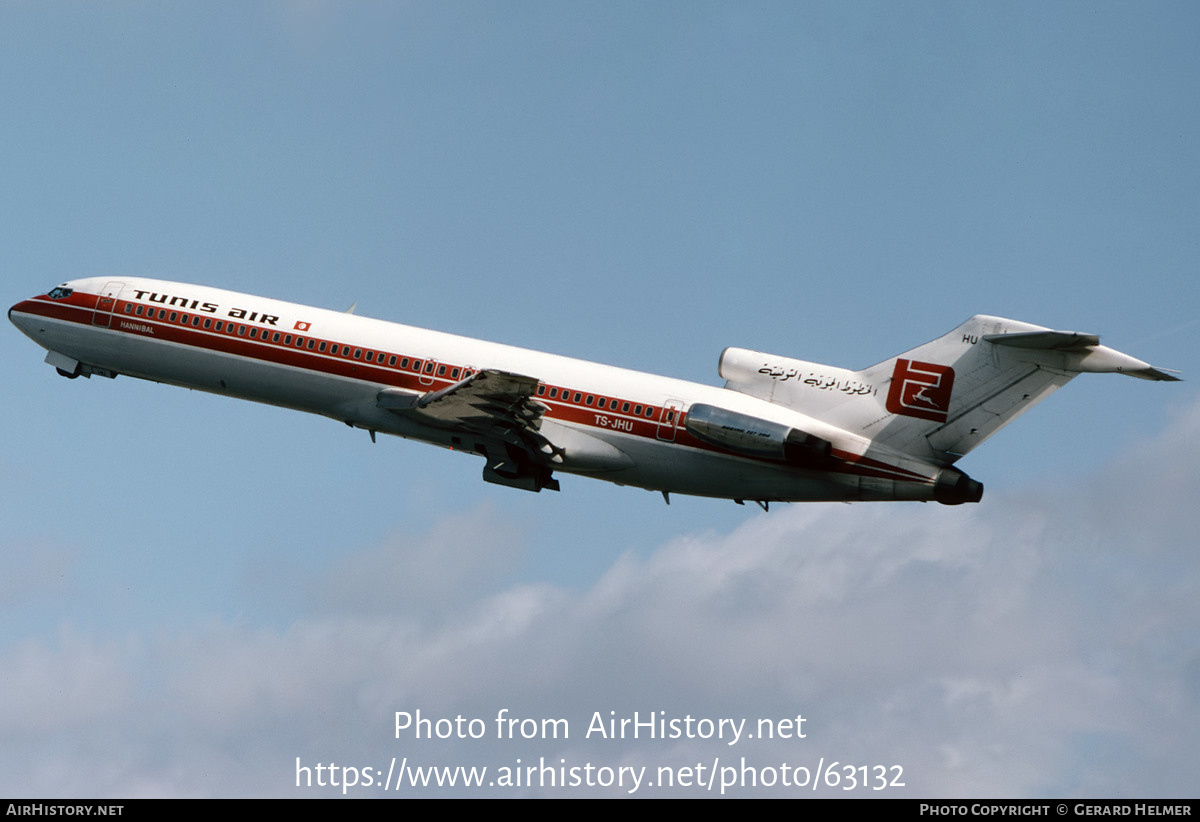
[376,368,563,491]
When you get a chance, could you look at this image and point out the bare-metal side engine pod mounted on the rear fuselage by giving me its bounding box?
[684,403,833,466]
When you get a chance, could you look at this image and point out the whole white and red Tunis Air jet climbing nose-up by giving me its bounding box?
[8,277,1178,509]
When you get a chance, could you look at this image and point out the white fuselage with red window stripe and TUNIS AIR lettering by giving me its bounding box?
[8,277,938,500]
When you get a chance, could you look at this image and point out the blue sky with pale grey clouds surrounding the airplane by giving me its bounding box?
[0,2,1200,797]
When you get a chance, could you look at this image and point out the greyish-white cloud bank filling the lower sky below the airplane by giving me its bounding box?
[0,403,1200,796]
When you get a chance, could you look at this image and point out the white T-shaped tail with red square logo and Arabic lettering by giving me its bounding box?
[721,314,1178,464]
